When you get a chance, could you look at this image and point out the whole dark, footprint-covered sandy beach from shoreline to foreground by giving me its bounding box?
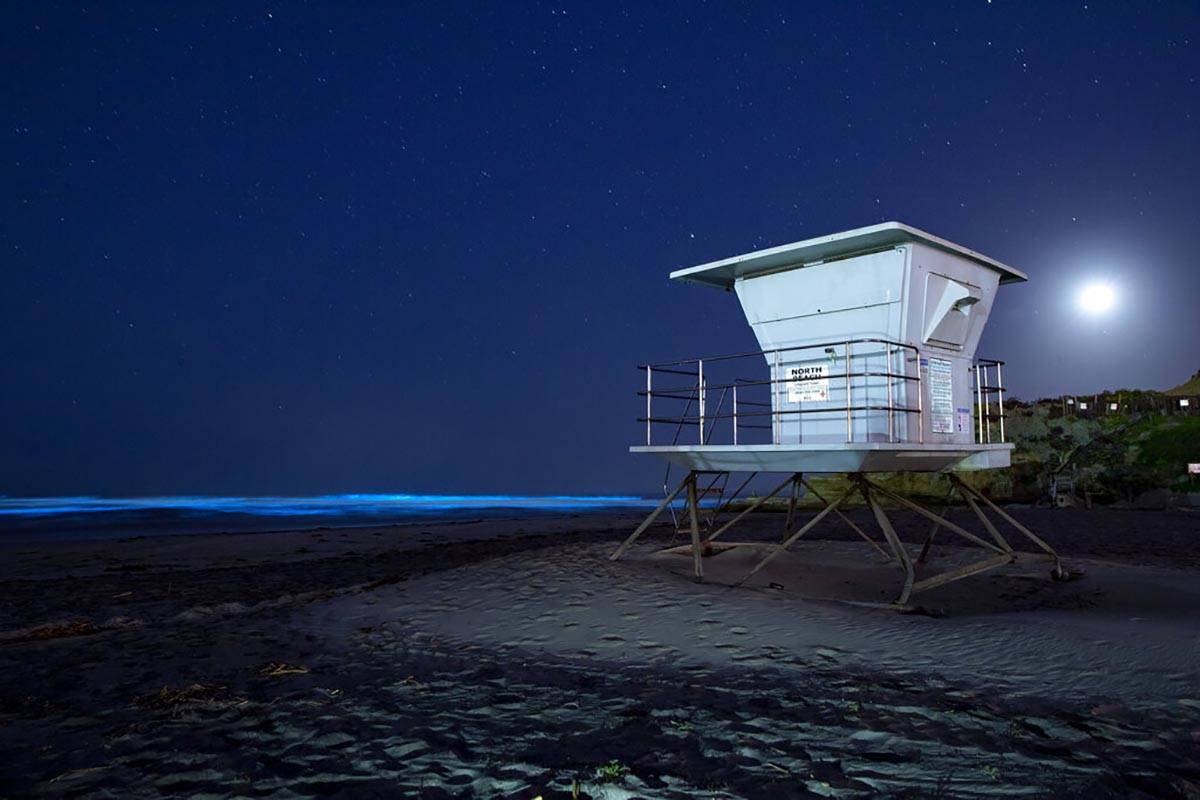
[0,509,1200,798]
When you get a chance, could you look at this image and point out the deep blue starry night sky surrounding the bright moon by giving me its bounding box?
[0,0,1200,495]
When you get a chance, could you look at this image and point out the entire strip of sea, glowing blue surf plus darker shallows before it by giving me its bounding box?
[0,494,658,541]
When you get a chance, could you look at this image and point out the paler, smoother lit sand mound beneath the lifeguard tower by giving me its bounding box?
[355,542,1200,703]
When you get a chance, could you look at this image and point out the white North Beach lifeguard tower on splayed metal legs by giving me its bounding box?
[612,222,1067,604]
